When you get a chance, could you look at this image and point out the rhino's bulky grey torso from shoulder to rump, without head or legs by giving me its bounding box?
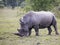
[23,11,54,26]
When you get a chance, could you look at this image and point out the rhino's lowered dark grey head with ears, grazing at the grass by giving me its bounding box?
[17,19,29,37]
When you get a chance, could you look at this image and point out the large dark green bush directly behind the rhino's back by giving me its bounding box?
[30,0,59,11]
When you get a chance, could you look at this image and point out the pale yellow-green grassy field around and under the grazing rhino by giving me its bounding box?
[0,8,60,45]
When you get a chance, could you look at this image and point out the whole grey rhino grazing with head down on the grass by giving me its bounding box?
[18,11,58,36]
